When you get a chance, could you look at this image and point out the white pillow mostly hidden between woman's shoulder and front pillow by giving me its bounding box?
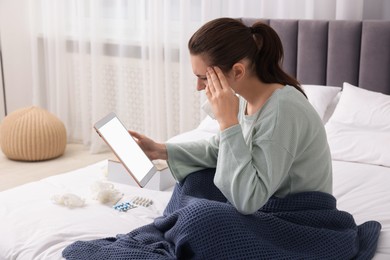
[301,85,341,123]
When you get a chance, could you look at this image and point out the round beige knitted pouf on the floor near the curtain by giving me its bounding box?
[0,106,66,161]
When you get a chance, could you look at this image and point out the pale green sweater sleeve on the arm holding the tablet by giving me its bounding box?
[166,134,219,182]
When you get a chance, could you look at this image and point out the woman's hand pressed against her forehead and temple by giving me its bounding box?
[205,67,239,131]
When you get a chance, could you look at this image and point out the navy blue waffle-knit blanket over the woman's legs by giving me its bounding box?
[63,169,381,260]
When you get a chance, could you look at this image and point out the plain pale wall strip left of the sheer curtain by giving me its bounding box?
[0,0,32,113]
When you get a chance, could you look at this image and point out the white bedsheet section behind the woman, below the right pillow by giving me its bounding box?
[333,161,390,260]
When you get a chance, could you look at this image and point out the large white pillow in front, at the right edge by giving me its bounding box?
[325,83,390,167]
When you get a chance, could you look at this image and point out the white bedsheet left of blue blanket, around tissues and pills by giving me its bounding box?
[0,161,171,260]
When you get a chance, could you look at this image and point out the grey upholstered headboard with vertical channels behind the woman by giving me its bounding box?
[241,18,390,94]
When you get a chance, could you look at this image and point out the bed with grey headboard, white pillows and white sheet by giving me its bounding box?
[0,18,390,259]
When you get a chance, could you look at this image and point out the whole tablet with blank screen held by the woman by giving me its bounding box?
[94,112,157,187]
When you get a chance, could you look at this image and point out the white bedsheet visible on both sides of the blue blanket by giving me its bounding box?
[0,161,390,260]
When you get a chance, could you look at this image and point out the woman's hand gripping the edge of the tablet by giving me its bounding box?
[129,130,168,160]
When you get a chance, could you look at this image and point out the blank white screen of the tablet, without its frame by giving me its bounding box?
[99,117,153,181]
